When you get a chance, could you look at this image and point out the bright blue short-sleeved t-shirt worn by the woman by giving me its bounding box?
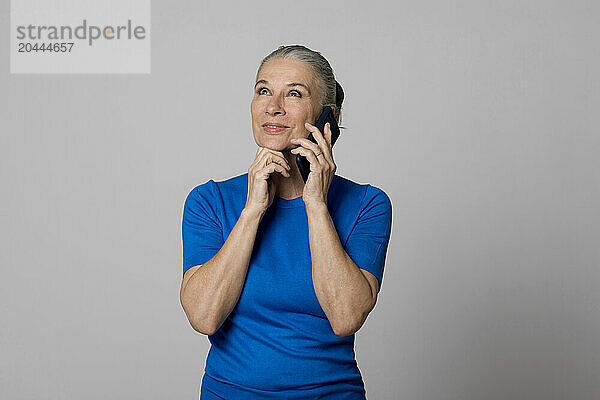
[182,173,392,400]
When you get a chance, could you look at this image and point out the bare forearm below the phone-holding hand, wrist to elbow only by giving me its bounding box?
[306,204,372,336]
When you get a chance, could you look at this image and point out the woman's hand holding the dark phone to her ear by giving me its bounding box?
[290,122,337,206]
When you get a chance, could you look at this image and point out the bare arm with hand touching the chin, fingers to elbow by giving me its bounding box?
[179,147,290,335]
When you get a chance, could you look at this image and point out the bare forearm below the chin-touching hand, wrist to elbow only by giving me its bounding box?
[181,209,262,334]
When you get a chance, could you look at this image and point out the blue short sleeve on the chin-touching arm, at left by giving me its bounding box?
[181,179,224,275]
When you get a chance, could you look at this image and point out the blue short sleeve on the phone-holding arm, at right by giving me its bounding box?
[345,185,392,288]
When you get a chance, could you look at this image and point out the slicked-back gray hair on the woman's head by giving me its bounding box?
[256,45,344,125]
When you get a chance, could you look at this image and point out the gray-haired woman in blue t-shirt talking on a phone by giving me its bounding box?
[180,46,392,400]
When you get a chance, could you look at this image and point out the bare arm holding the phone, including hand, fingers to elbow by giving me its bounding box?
[291,123,379,336]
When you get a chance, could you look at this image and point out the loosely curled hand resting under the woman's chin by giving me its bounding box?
[245,146,290,216]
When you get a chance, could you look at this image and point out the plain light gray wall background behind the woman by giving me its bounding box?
[0,1,600,400]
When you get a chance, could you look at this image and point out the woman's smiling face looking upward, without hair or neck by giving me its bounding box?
[250,58,320,151]
